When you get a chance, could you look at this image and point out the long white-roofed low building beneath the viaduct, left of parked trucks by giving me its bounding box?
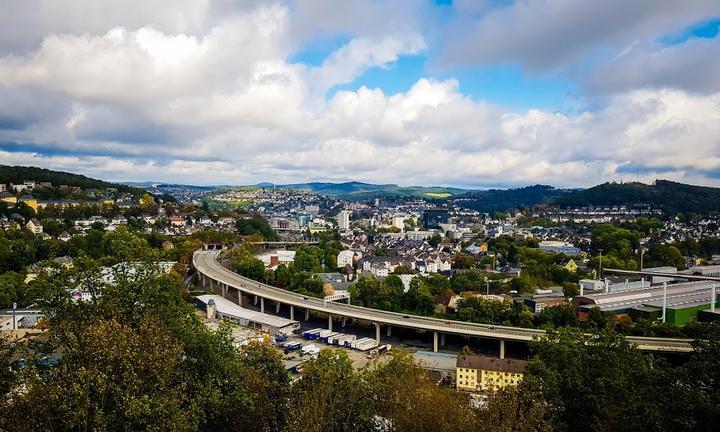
[195,294,300,335]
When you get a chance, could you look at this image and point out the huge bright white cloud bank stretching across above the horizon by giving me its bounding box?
[0,2,720,186]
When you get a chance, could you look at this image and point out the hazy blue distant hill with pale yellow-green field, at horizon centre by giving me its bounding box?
[255,182,467,201]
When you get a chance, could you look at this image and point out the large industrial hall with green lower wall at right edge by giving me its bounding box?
[573,281,720,325]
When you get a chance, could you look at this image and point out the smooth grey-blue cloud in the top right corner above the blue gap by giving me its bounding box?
[441,0,720,71]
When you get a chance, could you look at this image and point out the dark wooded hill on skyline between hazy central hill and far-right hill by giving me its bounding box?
[449,185,570,213]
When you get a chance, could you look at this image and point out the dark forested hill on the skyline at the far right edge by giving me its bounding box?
[553,180,720,215]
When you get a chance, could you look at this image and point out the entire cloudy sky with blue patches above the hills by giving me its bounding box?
[0,0,720,189]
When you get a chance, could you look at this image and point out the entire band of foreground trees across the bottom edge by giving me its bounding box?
[0,261,720,432]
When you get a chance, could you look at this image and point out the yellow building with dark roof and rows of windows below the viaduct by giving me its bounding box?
[455,355,527,391]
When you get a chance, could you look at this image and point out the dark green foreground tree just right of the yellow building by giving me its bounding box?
[522,328,663,430]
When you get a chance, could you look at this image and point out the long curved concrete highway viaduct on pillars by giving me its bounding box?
[193,250,692,357]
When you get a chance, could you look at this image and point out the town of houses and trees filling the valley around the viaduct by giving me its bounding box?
[0,169,720,408]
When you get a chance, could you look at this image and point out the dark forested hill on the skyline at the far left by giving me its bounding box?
[0,165,144,194]
